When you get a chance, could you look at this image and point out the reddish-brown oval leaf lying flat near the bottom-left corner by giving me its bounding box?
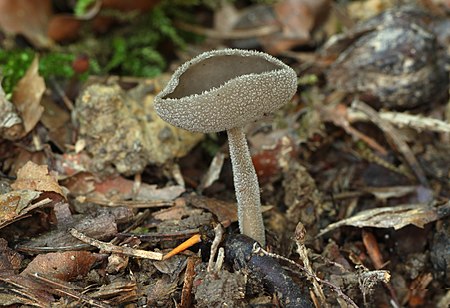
[21,251,97,281]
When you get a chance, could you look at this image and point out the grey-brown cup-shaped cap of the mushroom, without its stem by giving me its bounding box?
[155,49,297,133]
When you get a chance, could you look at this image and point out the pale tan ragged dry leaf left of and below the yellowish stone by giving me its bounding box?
[11,161,65,196]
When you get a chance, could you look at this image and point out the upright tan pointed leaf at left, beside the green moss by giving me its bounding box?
[12,57,45,135]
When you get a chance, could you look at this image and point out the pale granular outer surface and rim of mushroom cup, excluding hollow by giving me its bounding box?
[154,49,297,133]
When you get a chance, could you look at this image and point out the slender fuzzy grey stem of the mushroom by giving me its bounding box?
[227,127,266,247]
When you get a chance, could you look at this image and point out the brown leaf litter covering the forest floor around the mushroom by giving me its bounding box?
[0,0,450,307]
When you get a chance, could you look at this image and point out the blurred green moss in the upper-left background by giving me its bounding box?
[0,0,204,93]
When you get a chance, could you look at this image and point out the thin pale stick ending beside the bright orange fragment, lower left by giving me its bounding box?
[69,228,163,260]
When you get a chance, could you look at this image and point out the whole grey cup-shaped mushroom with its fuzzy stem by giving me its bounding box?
[154,49,297,246]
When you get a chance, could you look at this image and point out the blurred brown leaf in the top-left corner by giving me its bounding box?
[0,0,51,47]
